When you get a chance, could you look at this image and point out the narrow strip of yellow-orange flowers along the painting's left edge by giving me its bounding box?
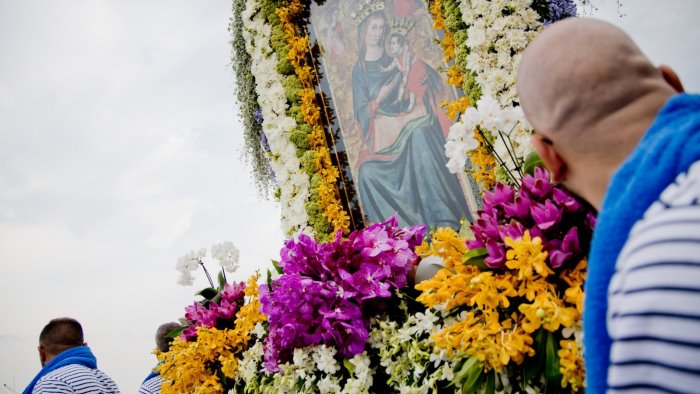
[276,0,350,233]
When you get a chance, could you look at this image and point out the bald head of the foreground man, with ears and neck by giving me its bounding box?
[517,18,682,206]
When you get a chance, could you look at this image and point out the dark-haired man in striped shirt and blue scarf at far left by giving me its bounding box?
[23,317,119,394]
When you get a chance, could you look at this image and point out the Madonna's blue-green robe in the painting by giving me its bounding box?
[352,54,471,229]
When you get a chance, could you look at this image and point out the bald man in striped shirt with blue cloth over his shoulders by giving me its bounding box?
[517,18,700,394]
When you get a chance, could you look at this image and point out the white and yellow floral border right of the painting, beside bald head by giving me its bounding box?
[430,0,576,190]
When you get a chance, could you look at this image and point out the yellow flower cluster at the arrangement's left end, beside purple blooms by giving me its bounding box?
[157,275,265,394]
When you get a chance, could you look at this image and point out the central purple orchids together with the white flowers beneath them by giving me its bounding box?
[230,218,425,393]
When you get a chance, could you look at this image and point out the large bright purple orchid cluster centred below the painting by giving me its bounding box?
[260,217,425,371]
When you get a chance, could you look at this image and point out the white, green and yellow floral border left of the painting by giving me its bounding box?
[235,0,349,239]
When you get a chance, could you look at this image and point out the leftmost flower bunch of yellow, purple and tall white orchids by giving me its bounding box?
[156,242,265,393]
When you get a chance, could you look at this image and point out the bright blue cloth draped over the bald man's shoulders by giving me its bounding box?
[583,94,700,394]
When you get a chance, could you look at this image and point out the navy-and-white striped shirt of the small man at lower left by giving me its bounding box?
[32,364,119,394]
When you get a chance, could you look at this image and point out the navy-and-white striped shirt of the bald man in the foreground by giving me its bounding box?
[607,162,700,393]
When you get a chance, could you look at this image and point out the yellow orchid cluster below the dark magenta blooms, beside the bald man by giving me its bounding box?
[416,228,586,382]
